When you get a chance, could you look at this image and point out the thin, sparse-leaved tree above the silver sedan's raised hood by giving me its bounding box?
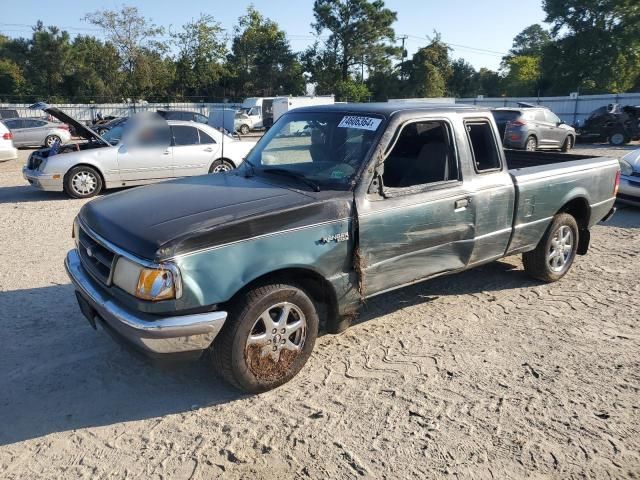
[84,5,167,97]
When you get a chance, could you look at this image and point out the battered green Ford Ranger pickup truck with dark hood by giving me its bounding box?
[66,103,619,392]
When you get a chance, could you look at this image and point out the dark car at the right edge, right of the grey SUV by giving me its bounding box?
[578,103,640,146]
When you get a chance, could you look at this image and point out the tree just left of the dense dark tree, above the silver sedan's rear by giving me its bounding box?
[173,14,228,97]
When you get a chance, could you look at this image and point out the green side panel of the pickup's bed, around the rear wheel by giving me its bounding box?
[508,158,619,254]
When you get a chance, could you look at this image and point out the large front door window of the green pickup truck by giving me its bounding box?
[382,121,460,188]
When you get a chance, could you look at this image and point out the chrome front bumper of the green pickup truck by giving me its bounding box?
[64,249,227,354]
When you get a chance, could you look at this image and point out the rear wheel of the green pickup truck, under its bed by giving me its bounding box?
[522,213,580,282]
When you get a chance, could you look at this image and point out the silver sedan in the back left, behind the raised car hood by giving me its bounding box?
[1,118,71,147]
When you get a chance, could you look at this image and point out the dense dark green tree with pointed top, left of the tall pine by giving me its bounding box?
[228,6,305,96]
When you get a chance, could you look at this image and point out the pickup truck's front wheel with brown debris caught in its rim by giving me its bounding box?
[211,284,319,393]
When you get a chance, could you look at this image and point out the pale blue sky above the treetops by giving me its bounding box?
[0,0,544,70]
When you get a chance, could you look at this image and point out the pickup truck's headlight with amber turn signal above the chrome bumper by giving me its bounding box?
[113,257,179,302]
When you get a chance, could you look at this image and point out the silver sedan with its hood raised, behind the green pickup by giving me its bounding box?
[23,105,255,198]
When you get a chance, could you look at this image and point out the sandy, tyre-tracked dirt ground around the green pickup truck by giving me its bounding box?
[0,147,640,479]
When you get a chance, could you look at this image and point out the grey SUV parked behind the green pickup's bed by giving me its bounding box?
[491,107,576,152]
